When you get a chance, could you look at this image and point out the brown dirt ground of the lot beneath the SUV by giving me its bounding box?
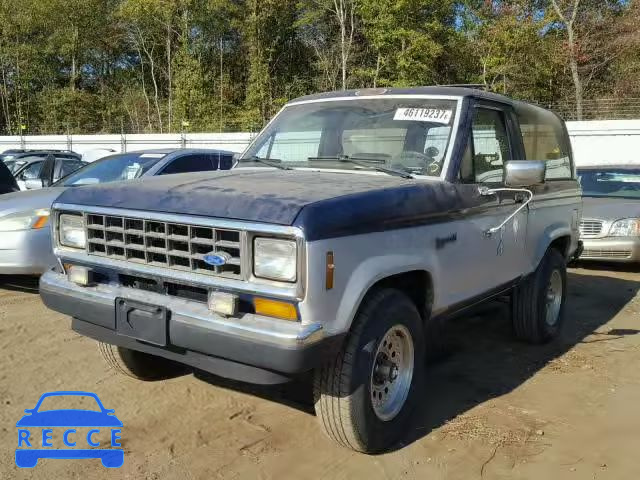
[0,267,640,480]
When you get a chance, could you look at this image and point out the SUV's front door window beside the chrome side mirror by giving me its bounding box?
[472,108,512,183]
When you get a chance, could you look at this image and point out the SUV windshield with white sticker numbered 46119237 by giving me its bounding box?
[238,97,457,176]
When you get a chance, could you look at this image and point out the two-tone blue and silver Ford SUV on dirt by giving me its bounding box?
[40,87,581,452]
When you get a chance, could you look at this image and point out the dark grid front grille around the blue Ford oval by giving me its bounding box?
[85,214,243,278]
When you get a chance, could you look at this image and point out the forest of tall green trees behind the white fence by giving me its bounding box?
[0,0,640,135]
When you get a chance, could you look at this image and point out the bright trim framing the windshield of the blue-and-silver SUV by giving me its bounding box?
[238,94,464,180]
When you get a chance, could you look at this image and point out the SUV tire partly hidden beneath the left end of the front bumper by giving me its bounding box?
[99,342,187,382]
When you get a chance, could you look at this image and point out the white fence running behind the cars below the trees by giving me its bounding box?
[0,120,640,165]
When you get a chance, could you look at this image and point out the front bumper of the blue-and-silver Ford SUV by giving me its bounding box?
[40,271,343,384]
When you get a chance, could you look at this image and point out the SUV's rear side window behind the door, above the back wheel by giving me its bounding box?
[517,106,573,180]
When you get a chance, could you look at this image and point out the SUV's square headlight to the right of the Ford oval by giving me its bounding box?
[253,238,298,282]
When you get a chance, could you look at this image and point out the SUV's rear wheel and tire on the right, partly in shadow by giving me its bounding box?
[511,248,567,344]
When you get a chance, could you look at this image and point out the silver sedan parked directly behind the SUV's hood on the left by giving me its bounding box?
[0,149,233,275]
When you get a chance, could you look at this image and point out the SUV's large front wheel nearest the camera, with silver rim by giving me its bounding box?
[314,289,425,453]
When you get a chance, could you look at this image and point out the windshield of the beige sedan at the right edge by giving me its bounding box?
[578,168,640,199]
